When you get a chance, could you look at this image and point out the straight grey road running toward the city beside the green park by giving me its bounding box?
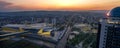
[56,26,71,48]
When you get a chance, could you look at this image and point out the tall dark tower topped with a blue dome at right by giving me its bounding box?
[97,7,120,48]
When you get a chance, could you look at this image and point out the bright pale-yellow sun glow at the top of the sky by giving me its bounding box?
[53,0,85,7]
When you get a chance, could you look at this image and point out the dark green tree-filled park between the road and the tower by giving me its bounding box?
[68,28,97,48]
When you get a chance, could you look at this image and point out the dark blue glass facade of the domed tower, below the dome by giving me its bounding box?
[105,24,120,48]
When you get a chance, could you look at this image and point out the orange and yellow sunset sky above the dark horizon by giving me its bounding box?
[0,0,120,11]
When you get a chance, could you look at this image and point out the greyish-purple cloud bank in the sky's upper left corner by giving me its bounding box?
[0,0,24,12]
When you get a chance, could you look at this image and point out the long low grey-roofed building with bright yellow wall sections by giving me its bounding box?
[1,24,54,37]
